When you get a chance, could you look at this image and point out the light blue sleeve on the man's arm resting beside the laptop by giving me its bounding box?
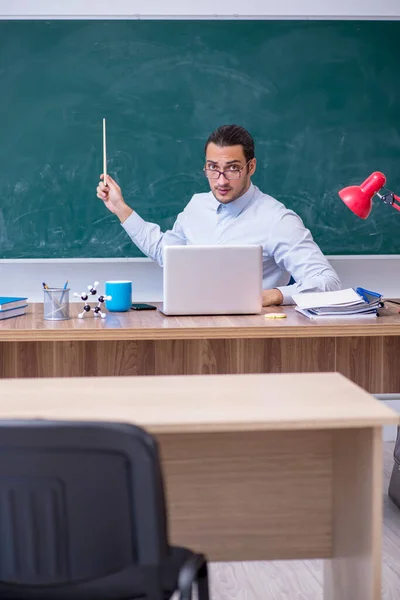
[268,209,341,304]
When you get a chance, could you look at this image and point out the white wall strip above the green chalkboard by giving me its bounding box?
[0,0,400,19]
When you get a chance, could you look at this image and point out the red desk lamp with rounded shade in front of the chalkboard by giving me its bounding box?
[339,171,400,219]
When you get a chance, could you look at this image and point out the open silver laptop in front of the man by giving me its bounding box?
[161,246,262,315]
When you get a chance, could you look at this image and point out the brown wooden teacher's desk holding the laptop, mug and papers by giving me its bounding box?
[0,304,400,393]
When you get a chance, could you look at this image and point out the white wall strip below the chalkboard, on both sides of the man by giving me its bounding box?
[0,256,400,302]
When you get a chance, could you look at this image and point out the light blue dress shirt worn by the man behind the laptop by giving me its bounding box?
[122,184,340,304]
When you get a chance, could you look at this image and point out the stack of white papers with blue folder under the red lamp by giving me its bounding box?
[293,288,383,319]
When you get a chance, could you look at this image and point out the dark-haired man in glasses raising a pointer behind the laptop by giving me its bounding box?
[97,125,340,306]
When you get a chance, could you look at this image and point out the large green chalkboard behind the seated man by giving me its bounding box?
[0,20,400,258]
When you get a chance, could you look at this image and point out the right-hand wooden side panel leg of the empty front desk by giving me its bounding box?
[324,427,382,600]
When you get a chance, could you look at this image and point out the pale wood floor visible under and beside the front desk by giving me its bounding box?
[211,442,400,600]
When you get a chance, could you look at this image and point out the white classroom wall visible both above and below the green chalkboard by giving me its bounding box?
[0,0,400,302]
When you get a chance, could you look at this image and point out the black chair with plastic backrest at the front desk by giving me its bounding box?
[0,420,209,600]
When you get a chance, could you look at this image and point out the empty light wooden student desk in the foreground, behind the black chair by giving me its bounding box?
[0,374,399,600]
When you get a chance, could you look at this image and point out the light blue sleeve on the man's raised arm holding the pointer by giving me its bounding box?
[122,212,186,267]
